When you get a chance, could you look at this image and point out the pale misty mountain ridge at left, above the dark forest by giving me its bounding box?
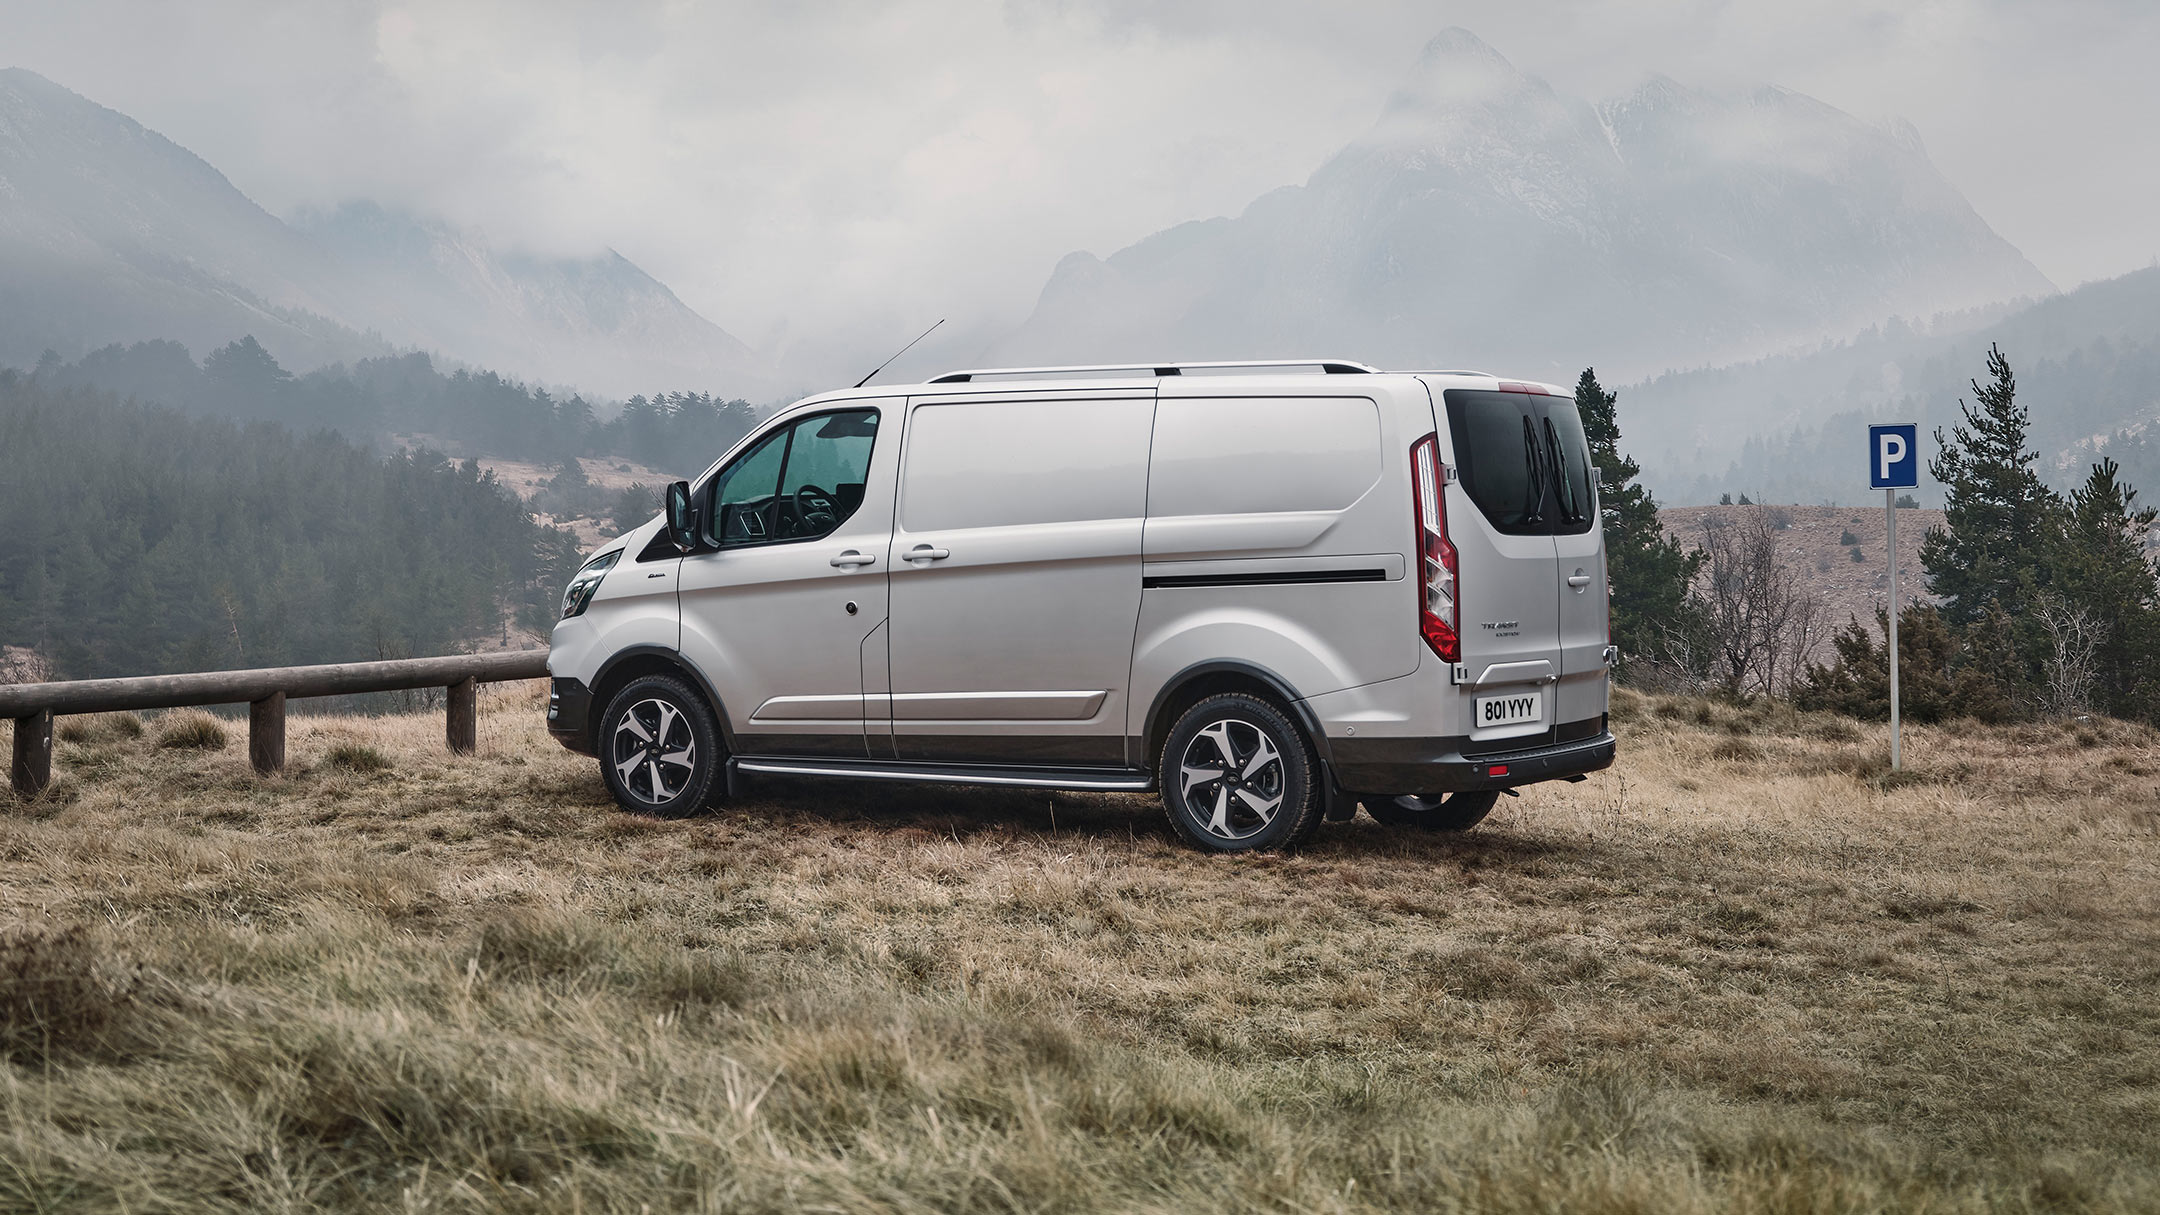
[0,69,758,393]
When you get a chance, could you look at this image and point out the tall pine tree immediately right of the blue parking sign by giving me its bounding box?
[1920,346,2063,622]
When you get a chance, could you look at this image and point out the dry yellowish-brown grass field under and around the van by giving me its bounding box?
[0,690,2160,1215]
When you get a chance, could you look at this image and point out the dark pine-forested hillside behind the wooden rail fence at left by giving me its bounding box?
[0,372,579,679]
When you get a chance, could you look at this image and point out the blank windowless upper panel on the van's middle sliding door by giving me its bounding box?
[901,398,1156,534]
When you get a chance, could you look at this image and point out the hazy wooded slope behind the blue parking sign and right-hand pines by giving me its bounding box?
[1618,266,2160,504]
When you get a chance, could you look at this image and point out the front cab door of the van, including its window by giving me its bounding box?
[678,400,901,759]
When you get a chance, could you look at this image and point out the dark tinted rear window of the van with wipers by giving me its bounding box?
[1445,389,1596,536]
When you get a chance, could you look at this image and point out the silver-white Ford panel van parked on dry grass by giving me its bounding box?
[549,361,1616,852]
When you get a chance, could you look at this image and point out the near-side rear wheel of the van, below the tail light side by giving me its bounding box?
[1156,692,1324,852]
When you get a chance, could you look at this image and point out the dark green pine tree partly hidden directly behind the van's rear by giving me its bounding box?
[1575,368,1702,657]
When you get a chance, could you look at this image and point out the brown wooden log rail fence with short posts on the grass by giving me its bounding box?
[0,651,546,798]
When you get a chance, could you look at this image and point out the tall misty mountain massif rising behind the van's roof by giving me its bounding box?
[1000,30,2054,380]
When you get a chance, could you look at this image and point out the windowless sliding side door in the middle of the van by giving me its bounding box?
[890,389,1156,765]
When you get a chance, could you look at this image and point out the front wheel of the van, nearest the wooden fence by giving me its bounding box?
[596,675,728,819]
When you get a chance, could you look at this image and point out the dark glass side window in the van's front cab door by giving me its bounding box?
[713,409,877,547]
